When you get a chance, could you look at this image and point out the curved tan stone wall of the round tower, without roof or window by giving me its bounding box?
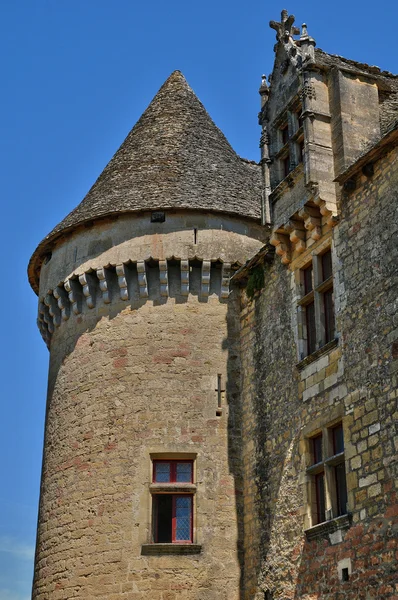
[33,213,262,600]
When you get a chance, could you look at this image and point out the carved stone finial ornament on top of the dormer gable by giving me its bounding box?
[269,8,316,70]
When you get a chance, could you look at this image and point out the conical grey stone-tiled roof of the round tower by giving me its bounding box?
[29,71,261,289]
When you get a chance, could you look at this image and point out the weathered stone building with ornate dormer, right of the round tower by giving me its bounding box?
[233,13,398,600]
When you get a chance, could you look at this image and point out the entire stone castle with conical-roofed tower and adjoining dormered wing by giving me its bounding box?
[29,11,398,600]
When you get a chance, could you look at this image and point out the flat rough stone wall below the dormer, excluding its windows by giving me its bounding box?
[241,143,398,600]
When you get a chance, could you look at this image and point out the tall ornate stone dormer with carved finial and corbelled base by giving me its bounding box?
[259,10,398,264]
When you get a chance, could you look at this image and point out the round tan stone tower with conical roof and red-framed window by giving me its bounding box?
[29,71,265,600]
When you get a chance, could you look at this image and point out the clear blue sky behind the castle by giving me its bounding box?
[0,0,398,600]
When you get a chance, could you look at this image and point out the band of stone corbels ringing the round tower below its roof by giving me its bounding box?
[37,257,235,347]
